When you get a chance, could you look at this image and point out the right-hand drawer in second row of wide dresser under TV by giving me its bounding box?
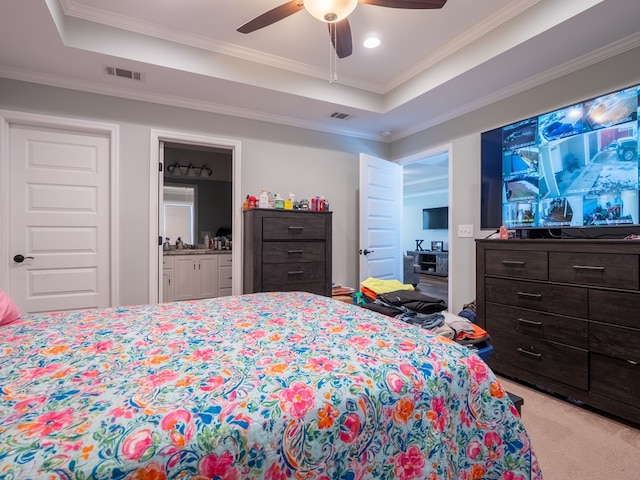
[589,290,640,328]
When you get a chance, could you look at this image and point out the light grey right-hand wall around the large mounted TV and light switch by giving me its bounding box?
[387,44,640,311]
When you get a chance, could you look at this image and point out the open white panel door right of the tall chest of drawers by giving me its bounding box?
[359,153,403,282]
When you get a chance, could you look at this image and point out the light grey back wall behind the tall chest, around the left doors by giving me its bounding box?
[0,78,388,304]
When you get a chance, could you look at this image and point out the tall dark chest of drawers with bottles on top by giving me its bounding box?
[243,209,332,297]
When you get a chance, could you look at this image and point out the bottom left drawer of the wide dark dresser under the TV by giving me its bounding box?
[489,332,589,390]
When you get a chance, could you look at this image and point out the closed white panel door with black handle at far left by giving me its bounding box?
[9,124,111,313]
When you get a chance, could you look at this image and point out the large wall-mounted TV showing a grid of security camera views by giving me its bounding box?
[480,85,640,229]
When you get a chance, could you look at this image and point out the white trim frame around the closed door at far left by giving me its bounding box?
[0,109,120,306]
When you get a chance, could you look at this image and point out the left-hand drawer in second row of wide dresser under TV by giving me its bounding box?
[485,278,588,318]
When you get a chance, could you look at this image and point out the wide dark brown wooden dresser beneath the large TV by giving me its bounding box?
[476,239,640,424]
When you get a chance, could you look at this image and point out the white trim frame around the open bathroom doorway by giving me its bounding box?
[149,129,242,303]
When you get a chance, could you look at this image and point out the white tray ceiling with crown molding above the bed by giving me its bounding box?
[0,0,640,141]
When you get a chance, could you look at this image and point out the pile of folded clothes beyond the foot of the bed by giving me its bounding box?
[354,277,493,358]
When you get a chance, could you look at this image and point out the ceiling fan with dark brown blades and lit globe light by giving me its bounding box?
[237,0,447,58]
